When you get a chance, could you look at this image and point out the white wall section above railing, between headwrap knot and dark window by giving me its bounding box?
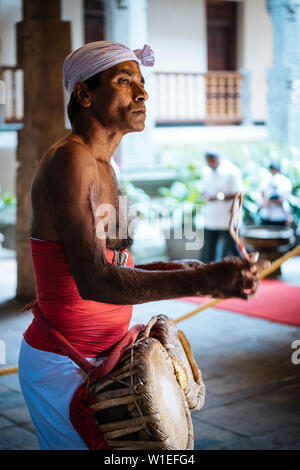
[148,0,207,72]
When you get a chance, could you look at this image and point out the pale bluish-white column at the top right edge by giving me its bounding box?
[267,0,300,148]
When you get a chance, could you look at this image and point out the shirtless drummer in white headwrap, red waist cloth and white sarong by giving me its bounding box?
[19,41,262,449]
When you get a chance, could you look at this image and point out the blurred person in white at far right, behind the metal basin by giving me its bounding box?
[259,162,292,226]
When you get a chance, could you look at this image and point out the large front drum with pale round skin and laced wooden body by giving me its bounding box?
[91,319,194,450]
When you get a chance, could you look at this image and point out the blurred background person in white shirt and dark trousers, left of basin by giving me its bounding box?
[202,151,243,263]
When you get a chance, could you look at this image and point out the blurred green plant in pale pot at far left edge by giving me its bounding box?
[0,192,17,250]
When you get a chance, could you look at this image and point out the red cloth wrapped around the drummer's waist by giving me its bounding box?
[24,239,133,357]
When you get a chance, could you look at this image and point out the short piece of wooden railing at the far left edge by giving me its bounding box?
[0,66,23,124]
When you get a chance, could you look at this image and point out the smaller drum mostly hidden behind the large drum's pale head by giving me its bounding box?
[151,315,205,410]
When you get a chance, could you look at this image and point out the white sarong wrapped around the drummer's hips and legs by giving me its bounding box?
[19,339,100,450]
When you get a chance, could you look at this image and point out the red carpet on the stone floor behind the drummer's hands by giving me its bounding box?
[180,279,300,326]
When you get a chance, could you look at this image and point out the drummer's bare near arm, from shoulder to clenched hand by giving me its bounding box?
[46,144,264,305]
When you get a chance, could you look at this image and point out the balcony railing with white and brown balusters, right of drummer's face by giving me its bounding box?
[154,71,243,124]
